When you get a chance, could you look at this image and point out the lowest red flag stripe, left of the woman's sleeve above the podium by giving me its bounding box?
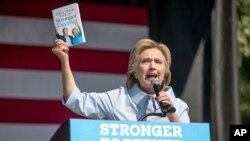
[0,98,84,124]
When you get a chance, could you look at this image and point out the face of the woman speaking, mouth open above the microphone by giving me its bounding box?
[135,48,166,94]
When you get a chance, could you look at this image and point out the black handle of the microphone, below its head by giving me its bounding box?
[153,84,176,114]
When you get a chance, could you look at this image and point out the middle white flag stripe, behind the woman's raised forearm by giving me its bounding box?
[0,69,126,99]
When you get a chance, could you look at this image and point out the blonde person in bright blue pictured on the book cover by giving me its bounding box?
[72,24,83,45]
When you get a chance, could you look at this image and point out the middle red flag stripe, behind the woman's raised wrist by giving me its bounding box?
[0,44,129,74]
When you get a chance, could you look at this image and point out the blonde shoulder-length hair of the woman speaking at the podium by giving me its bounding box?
[126,39,171,89]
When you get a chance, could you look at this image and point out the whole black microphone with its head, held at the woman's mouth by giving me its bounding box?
[151,79,176,115]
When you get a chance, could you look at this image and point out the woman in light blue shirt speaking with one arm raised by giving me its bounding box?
[52,39,190,122]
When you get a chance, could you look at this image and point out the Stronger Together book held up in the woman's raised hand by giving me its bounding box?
[52,3,86,47]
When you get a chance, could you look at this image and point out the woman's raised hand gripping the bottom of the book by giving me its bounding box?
[52,39,69,62]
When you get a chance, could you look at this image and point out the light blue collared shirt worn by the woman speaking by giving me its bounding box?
[63,85,190,123]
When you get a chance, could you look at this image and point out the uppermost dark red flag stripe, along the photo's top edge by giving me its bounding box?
[0,0,148,25]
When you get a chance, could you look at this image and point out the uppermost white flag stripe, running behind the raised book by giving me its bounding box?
[0,16,148,51]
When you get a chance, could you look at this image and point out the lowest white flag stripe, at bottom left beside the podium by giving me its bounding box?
[0,123,59,141]
